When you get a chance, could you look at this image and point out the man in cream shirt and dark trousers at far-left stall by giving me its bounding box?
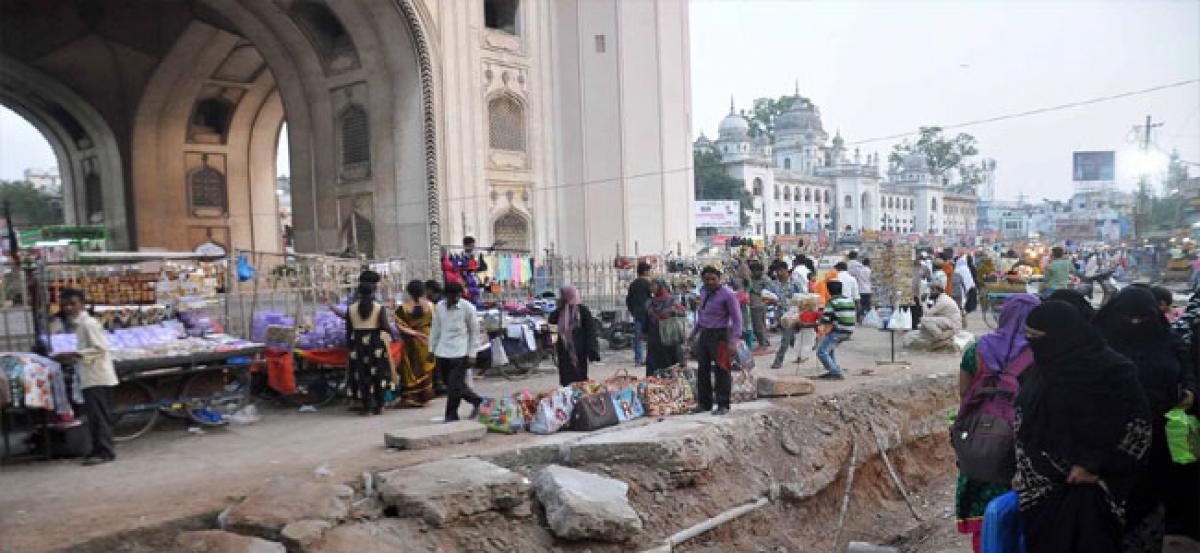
[54,289,118,465]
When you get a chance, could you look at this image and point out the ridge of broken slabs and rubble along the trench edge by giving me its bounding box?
[162,375,954,553]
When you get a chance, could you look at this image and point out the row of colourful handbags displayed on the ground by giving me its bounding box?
[479,365,757,434]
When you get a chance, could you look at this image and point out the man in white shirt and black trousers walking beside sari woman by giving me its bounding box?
[430,282,482,422]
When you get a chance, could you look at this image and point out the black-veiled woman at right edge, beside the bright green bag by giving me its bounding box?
[1093,287,1195,552]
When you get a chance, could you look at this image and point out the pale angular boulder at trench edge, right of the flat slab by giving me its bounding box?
[534,464,642,542]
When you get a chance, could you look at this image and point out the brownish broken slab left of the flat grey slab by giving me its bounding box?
[224,476,350,539]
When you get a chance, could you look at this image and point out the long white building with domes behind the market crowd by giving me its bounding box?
[695,92,978,238]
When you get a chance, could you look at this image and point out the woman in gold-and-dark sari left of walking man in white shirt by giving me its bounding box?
[396,281,434,408]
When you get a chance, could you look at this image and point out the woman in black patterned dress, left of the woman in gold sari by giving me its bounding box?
[346,282,395,415]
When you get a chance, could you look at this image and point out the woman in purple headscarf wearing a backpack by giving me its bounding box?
[954,294,1039,553]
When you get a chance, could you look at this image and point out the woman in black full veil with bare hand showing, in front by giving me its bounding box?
[1016,301,1151,553]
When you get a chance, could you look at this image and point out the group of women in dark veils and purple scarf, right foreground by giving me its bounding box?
[952,281,1200,553]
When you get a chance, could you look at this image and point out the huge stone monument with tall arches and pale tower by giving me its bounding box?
[0,0,691,258]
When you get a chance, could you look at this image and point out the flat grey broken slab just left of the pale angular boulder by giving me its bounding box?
[378,457,529,527]
